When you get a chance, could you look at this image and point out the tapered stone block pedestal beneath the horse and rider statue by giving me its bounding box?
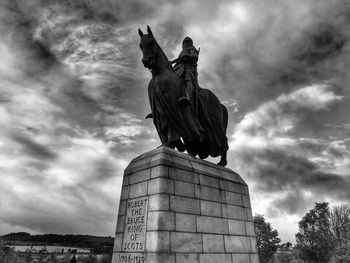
[112,147,259,263]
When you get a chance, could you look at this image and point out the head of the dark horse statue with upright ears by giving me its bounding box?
[139,26,158,69]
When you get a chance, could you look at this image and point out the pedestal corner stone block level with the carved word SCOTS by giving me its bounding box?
[146,231,170,252]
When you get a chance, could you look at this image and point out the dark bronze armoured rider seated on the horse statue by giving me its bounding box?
[174,37,199,108]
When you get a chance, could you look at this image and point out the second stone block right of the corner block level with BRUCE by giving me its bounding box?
[197,216,228,234]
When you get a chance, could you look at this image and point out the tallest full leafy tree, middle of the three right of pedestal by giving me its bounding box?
[296,202,335,263]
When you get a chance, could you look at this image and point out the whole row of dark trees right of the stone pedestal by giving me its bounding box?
[254,202,350,263]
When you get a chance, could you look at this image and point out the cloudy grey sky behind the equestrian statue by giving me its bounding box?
[0,0,350,242]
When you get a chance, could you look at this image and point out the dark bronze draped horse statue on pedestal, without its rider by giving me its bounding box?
[138,26,228,166]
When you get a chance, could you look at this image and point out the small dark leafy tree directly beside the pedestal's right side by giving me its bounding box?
[254,215,281,263]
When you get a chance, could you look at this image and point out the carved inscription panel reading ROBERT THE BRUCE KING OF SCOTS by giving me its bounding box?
[120,197,148,253]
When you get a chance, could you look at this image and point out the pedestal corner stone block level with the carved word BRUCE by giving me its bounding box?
[147,211,175,231]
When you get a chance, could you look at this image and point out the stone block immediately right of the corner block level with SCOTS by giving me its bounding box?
[171,232,203,253]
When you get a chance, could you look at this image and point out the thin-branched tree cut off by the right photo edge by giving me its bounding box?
[330,205,350,258]
